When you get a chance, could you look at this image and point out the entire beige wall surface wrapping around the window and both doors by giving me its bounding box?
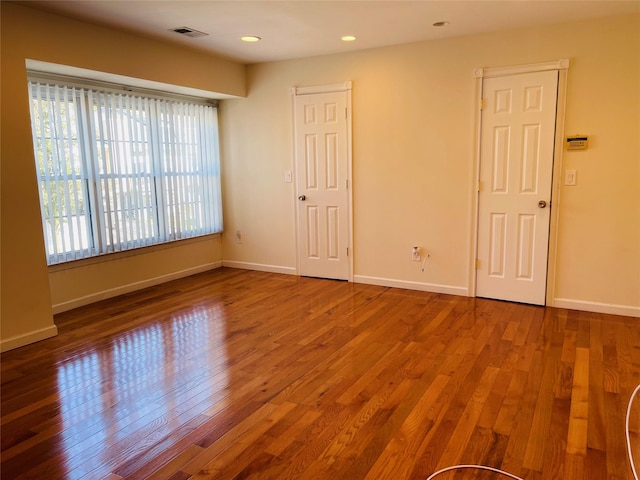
[0,2,640,349]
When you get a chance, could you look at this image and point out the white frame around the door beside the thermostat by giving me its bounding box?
[468,58,569,306]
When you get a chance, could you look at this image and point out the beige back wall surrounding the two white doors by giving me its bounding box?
[222,16,640,316]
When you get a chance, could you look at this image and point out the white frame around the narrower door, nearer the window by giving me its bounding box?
[289,81,354,282]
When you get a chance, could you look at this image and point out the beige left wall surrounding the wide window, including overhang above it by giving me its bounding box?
[0,2,246,350]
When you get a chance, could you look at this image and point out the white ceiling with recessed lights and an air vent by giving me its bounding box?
[21,0,640,64]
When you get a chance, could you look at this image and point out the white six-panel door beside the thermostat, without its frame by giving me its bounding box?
[476,70,558,305]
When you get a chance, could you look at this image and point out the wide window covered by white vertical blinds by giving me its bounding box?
[29,79,222,265]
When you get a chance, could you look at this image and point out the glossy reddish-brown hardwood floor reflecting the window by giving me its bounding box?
[1,269,640,480]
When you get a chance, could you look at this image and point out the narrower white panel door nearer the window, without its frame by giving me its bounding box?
[294,91,350,280]
